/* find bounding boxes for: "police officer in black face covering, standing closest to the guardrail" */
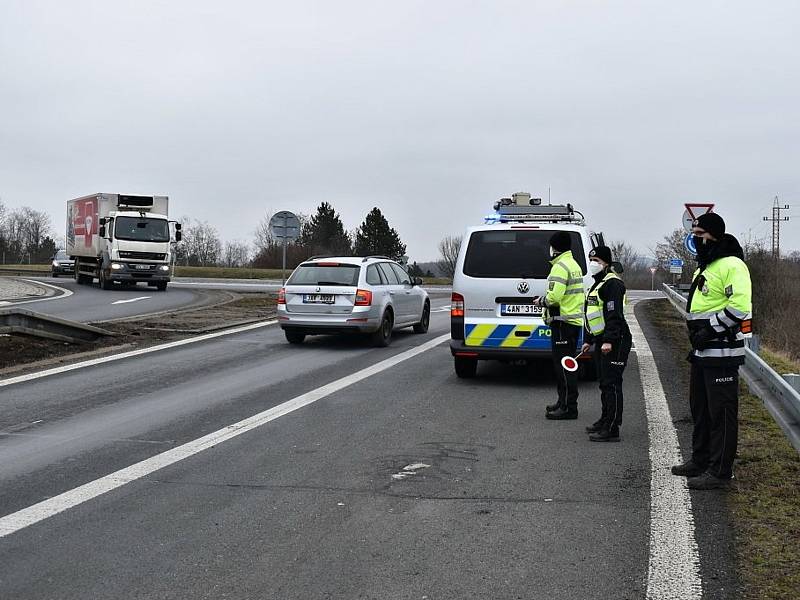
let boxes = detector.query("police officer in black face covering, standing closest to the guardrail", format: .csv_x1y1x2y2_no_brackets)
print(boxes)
672,213,752,489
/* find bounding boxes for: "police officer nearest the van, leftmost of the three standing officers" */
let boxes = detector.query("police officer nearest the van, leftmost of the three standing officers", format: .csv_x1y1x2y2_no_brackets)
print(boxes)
534,231,585,420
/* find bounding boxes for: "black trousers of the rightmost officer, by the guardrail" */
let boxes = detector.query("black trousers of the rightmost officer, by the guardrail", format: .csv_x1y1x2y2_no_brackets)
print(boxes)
689,362,739,479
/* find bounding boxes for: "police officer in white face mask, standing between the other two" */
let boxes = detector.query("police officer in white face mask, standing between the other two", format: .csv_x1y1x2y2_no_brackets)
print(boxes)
581,246,633,442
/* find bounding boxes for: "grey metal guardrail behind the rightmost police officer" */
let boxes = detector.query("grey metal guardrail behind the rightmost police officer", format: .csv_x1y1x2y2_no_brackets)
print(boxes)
663,283,800,452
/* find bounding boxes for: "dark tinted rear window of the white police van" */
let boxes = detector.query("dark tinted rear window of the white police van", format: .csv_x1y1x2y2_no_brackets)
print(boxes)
464,229,586,279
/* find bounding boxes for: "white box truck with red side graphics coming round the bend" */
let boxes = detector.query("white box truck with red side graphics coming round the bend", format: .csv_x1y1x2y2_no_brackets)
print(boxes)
66,194,181,291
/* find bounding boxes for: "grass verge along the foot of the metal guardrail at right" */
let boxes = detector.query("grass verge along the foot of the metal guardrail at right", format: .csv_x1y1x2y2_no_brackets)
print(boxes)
648,301,800,600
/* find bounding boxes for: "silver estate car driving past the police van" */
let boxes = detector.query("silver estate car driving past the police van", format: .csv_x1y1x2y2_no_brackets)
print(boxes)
278,256,431,346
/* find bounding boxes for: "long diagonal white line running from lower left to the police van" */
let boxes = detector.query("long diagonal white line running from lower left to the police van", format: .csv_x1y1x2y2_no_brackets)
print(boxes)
0,333,450,537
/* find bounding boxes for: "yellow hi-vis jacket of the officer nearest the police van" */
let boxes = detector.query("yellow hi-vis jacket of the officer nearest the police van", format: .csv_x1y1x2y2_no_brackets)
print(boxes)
544,251,586,327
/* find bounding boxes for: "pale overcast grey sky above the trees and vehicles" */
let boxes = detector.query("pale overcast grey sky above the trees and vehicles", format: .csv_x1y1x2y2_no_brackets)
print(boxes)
0,0,800,260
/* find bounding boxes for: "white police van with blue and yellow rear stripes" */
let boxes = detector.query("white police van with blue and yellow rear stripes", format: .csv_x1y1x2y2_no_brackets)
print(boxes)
450,192,603,377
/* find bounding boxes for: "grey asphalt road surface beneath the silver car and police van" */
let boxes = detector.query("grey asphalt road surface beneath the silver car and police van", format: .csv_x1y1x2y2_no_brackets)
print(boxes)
0,294,668,599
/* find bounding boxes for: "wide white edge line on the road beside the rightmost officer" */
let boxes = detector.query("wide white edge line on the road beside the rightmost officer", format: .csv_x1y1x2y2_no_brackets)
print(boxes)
627,308,703,600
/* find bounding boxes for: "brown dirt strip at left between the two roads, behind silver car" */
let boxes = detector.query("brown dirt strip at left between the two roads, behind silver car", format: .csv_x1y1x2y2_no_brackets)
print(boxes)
0,292,276,378
